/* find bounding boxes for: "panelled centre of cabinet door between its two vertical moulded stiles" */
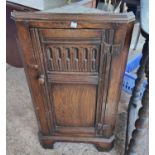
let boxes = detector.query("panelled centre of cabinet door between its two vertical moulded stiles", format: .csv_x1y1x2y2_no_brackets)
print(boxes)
34,29,101,135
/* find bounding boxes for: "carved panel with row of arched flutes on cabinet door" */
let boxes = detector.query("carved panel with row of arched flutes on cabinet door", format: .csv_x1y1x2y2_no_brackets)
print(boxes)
45,44,100,72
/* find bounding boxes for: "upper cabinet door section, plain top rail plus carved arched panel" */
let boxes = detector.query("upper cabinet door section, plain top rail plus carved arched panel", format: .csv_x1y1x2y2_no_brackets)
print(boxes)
39,29,101,72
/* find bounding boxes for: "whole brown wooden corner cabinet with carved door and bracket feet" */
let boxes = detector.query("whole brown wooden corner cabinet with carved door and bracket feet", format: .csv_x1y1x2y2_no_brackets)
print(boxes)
12,12,134,149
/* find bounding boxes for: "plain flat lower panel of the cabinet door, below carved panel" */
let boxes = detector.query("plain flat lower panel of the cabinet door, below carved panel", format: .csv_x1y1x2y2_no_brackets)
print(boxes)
51,84,96,127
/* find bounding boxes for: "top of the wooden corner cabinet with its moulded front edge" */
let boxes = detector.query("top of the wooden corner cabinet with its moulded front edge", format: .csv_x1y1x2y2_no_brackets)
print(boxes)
11,6,135,23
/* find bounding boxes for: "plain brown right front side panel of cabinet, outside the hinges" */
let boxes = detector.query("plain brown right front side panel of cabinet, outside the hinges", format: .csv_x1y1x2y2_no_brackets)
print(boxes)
103,22,133,137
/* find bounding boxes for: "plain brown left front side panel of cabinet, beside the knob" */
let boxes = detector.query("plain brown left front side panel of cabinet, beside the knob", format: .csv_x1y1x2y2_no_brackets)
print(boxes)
16,21,50,135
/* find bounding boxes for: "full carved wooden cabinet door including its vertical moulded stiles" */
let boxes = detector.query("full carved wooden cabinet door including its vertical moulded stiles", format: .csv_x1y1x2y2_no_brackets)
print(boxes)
30,28,128,136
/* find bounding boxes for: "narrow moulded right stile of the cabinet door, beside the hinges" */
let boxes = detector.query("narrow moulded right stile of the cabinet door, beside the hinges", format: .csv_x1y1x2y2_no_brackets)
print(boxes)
96,30,113,136
